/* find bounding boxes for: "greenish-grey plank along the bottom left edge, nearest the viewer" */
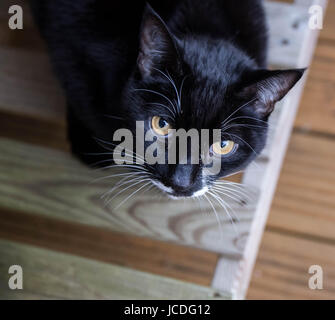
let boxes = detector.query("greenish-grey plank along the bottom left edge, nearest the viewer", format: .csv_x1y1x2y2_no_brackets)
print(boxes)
0,240,229,300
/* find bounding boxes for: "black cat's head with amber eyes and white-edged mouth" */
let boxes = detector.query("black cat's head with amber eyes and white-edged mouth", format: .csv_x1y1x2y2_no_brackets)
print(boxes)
119,7,304,197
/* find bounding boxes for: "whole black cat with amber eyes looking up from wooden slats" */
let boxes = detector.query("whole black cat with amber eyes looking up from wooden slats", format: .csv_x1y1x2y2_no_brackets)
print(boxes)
31,0,304,197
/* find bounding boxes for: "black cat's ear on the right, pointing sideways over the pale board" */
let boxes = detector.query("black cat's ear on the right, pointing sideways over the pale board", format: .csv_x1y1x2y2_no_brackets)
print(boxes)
239,69,306,117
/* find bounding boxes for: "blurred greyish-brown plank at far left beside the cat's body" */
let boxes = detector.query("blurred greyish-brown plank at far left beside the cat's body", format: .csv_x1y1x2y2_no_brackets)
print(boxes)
0,47,65,127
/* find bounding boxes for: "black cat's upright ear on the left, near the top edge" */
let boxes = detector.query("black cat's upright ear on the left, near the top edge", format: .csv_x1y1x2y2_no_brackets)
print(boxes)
137,4,179,77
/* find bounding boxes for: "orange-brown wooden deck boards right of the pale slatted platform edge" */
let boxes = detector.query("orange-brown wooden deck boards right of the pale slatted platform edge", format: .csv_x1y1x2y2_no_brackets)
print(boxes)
247,0,335,299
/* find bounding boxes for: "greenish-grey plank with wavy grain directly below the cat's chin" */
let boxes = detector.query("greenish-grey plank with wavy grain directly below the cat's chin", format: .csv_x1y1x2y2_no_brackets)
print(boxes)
0,139,257,258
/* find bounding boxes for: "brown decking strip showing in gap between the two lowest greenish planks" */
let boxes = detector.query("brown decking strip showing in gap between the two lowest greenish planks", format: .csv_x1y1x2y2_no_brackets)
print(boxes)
0,208,217,286
